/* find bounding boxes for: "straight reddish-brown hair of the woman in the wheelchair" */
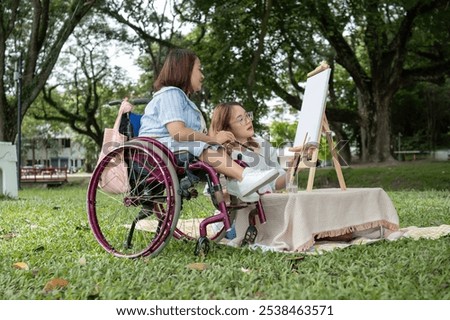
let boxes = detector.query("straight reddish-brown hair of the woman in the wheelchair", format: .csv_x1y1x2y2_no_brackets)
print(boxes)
153,48,198,94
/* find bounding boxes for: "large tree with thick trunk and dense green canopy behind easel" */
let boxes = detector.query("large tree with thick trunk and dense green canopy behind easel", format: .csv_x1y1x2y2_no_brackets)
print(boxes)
184,0,450,161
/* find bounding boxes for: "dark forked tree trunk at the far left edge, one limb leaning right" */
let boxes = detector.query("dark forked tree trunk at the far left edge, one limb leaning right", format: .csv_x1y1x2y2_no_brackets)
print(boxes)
0,0,95,142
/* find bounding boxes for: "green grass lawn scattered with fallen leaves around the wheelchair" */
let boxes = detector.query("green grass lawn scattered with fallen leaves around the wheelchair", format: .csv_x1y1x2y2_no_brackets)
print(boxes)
0,163,450,300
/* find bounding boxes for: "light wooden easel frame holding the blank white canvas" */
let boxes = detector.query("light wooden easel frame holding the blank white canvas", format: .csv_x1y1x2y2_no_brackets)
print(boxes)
289,62,347,191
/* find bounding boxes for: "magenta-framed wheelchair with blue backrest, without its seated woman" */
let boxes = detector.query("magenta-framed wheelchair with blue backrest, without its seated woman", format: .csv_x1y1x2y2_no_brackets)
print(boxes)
86,113,266,258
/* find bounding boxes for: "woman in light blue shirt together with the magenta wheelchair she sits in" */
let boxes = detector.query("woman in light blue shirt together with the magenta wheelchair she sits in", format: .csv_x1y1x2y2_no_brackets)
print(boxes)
87,49,279,258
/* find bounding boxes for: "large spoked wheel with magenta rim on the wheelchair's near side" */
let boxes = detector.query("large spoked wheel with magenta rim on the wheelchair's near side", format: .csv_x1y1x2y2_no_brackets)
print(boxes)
87,141,181,258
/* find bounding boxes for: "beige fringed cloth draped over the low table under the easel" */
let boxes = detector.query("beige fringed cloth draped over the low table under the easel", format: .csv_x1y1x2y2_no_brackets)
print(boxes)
229,188,399,251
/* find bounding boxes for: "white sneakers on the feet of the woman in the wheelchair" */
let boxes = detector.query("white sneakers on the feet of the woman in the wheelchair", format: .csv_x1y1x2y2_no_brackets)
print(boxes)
227,168,279,202
